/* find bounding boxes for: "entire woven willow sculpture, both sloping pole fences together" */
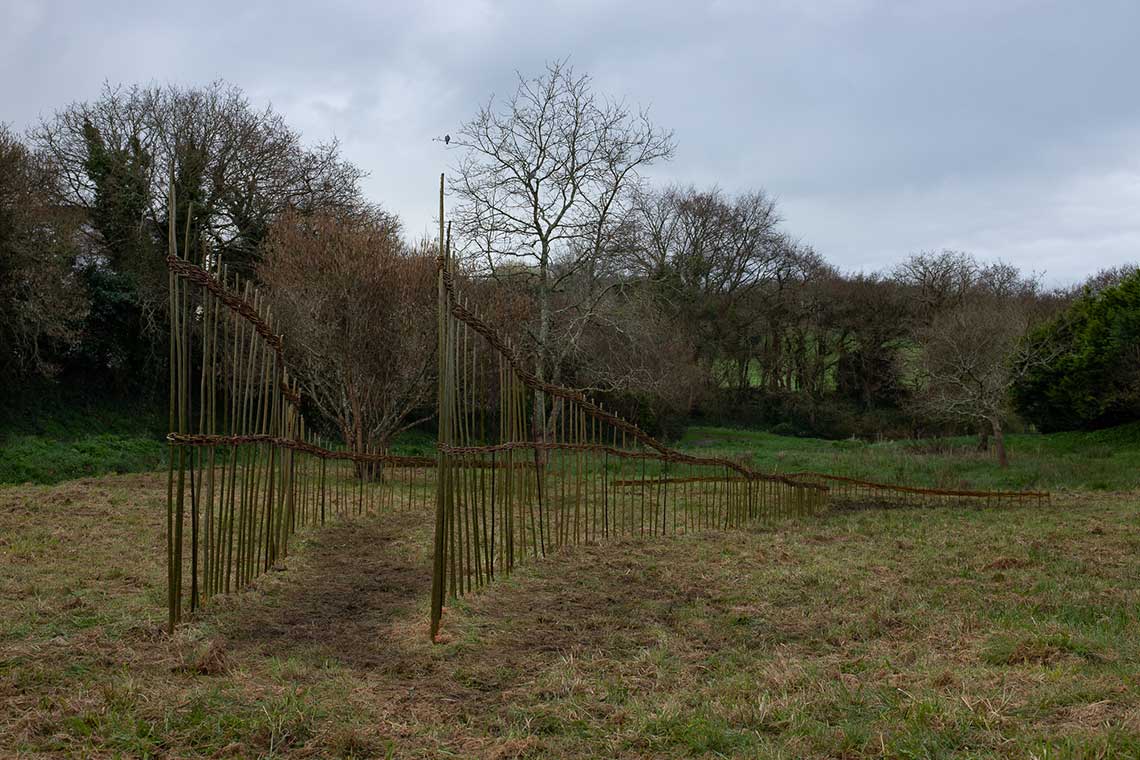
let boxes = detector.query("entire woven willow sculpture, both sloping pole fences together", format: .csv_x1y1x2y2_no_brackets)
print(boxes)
166,178,1049,638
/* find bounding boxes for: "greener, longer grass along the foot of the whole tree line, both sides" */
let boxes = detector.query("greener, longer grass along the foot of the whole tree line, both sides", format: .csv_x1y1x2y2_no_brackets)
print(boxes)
8,404,1140,491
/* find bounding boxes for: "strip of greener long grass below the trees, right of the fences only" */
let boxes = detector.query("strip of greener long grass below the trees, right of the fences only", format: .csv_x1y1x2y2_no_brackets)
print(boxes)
679,423,1140,491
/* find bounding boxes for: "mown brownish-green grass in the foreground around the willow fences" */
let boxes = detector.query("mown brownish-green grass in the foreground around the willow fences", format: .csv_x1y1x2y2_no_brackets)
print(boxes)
0,471,1140,758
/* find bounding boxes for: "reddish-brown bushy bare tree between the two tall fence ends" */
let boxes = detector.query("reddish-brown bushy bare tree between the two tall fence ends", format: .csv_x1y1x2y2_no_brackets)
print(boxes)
260,209,435,464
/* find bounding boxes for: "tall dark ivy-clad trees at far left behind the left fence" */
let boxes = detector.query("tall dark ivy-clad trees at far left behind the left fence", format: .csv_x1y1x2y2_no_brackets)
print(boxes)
0,82,361,393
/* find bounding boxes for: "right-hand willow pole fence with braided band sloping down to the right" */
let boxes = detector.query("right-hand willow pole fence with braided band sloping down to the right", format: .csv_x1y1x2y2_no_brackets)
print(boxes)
431,175,828,639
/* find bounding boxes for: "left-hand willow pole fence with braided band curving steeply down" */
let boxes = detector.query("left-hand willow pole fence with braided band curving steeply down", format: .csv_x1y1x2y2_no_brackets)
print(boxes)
166,184,435,629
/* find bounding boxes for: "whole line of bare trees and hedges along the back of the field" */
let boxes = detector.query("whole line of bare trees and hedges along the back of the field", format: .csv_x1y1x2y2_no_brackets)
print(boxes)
0,74,1140,460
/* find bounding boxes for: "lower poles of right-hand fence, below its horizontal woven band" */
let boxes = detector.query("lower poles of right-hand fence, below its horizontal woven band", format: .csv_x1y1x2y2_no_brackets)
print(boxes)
443,448,827,595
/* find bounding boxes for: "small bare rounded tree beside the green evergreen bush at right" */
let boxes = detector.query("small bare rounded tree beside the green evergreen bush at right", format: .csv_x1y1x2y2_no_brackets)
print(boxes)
903,278,1049,467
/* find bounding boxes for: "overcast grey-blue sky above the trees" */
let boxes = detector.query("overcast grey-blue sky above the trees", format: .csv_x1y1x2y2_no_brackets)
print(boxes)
0,0,1140,284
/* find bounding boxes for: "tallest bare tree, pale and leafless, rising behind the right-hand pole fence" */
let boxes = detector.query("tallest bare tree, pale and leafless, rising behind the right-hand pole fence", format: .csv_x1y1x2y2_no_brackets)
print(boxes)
450,63,673,435
